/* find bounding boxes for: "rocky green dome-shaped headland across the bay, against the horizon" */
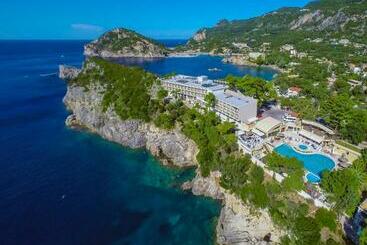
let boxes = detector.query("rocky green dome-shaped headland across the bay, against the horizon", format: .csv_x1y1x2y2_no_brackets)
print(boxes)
84,28,167,58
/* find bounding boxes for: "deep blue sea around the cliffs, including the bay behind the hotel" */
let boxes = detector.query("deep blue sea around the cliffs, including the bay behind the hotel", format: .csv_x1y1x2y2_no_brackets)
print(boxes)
0,41,274,245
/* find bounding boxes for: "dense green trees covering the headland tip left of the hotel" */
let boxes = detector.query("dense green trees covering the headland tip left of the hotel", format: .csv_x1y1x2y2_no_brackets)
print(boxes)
70,58,157,121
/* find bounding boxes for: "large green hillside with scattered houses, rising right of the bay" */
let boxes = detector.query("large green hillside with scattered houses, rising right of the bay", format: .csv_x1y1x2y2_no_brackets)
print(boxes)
185,0,367,144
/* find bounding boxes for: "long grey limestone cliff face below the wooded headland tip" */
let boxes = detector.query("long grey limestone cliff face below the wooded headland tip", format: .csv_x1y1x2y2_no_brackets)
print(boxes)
64,86,198,167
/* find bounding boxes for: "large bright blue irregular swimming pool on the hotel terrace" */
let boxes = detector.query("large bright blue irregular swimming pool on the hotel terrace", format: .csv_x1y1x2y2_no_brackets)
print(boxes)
274,144,335,183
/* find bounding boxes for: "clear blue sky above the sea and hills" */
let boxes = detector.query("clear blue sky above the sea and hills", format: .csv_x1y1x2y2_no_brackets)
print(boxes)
0,0,309,39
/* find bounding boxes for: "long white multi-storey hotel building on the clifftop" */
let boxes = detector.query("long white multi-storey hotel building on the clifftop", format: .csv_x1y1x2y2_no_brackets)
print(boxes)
162,75,257,123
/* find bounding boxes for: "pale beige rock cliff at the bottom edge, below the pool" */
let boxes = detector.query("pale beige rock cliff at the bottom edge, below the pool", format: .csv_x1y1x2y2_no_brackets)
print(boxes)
182,172,283,245
